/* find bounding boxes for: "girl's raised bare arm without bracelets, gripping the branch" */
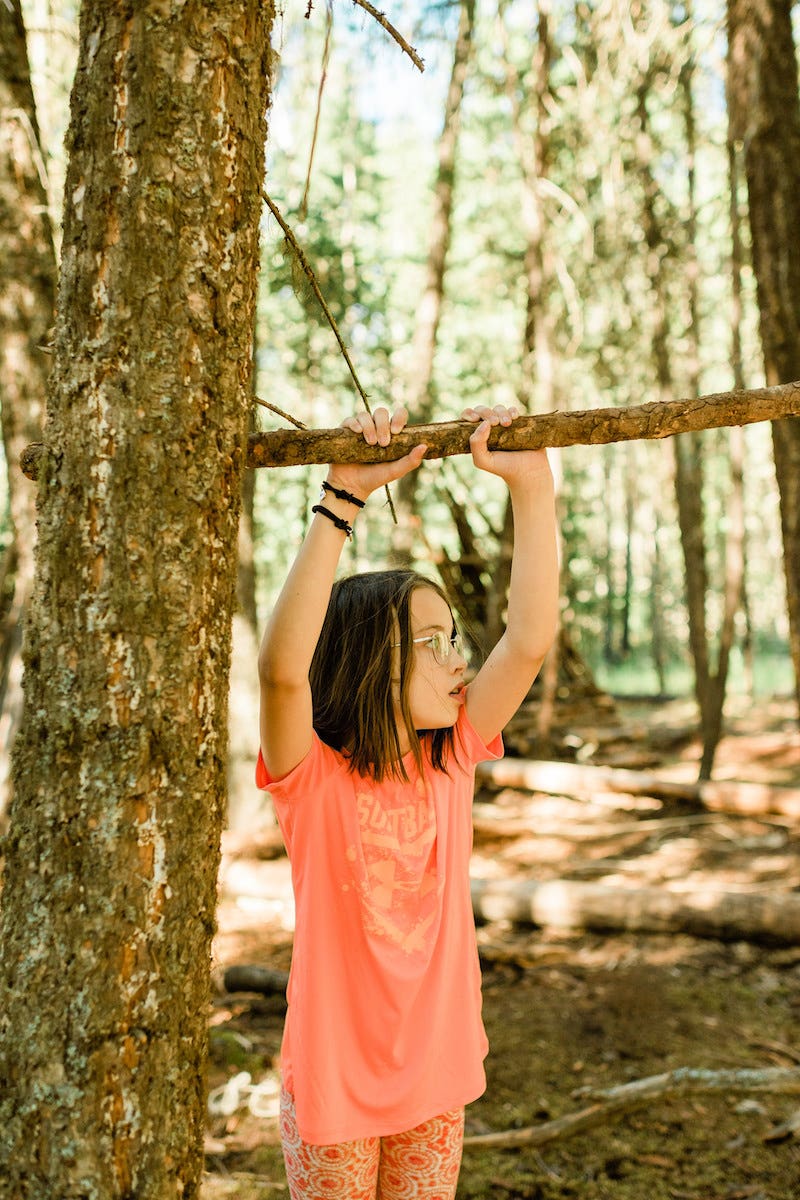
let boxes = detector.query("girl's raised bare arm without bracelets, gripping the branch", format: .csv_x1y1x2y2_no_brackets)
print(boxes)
463,406,559,742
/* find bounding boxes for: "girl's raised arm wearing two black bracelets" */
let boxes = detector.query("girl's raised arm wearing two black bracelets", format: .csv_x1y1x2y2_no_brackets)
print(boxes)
258,408,427,779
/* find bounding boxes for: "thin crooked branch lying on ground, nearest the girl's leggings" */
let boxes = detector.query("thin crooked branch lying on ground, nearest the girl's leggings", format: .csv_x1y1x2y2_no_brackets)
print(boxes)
464,1067,800,1150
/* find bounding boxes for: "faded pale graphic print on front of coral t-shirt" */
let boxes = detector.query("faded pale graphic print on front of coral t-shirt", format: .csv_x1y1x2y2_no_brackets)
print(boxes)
343,779,443,954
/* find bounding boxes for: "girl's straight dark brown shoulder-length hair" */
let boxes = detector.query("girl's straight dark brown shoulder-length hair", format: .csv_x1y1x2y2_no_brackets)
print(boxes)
309,570,453,782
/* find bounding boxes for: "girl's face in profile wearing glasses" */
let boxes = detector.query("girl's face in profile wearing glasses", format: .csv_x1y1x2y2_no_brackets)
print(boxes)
395,587,467,751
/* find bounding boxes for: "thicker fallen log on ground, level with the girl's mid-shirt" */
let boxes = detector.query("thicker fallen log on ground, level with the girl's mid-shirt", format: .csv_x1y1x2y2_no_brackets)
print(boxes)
471,880,800,946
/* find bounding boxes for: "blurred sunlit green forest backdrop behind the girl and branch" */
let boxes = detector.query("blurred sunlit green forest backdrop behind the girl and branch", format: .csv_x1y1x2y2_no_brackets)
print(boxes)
2,0,793,825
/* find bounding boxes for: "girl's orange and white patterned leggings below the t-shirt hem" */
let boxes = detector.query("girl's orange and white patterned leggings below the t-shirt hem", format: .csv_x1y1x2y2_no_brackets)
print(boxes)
281,1091,464,1200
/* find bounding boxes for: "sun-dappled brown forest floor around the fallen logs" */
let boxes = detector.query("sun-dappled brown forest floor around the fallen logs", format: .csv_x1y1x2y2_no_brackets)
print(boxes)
203,701,800,1200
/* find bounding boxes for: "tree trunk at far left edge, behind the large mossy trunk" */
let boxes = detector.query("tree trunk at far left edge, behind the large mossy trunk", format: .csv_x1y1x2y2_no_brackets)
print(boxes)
0,0,56,828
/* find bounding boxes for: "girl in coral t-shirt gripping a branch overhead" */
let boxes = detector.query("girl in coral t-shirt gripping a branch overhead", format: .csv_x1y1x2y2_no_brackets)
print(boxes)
257,407,558,1200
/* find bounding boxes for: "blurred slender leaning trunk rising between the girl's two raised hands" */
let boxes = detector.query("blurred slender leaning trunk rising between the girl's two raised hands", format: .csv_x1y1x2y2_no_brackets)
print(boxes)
392,0,475,566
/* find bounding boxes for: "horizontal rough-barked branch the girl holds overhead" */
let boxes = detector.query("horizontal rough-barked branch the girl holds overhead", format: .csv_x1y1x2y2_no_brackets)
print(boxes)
20,380,800,479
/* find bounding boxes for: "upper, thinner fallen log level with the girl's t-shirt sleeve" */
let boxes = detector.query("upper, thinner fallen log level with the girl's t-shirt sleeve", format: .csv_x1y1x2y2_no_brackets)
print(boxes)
477,758,800,818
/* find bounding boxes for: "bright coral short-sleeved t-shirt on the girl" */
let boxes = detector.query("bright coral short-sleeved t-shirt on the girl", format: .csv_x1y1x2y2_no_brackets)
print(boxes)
255,707,503,1145
